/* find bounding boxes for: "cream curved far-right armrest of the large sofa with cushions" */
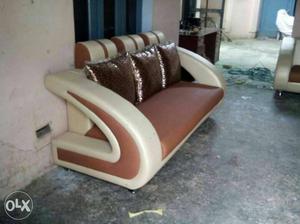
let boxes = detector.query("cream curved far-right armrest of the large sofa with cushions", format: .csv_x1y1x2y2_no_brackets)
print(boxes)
177,47,226,90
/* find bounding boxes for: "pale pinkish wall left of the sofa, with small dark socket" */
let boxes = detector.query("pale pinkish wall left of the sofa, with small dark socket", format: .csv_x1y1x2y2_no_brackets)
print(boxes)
0,0,74,197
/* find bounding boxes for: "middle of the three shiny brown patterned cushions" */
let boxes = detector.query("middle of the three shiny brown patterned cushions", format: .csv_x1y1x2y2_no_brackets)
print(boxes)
131,46,163,103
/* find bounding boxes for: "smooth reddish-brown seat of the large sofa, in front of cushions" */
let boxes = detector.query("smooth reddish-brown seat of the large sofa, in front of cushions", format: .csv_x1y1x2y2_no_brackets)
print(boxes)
137,82,224,158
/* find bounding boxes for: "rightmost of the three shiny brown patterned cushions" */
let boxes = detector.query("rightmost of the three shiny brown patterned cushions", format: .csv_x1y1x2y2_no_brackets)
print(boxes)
157,43,181,86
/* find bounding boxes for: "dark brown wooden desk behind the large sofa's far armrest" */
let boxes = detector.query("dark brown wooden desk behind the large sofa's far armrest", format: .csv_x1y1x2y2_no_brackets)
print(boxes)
179,28,221,64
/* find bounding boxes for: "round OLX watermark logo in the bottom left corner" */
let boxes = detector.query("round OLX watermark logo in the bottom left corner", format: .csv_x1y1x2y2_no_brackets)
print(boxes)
4,191,33,220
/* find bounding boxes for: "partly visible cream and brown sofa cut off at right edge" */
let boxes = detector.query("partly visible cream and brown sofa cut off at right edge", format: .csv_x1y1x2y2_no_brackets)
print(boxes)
274,37,300,96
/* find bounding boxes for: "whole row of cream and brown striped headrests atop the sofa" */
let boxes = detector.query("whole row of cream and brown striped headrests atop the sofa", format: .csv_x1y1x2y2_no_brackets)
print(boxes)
75,31,166,68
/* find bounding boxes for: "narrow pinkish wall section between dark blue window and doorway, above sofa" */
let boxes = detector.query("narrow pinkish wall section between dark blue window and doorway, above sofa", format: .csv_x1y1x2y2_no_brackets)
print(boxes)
152,0,181,43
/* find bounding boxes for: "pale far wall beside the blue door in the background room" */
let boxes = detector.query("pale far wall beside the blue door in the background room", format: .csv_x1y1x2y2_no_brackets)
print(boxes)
223,0,261,38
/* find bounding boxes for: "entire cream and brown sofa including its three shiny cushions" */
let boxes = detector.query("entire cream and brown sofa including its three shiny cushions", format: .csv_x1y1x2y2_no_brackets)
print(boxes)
45,31,225,189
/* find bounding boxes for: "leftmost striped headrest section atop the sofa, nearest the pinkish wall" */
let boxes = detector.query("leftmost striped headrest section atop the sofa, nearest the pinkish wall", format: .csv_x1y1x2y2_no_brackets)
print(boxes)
75,39,118,68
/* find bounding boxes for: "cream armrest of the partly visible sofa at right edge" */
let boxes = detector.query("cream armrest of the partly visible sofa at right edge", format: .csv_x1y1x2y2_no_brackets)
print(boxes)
274,37,295,90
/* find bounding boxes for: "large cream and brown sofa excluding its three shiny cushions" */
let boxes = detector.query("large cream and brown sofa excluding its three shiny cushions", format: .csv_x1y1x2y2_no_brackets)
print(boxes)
45,31,225,189
